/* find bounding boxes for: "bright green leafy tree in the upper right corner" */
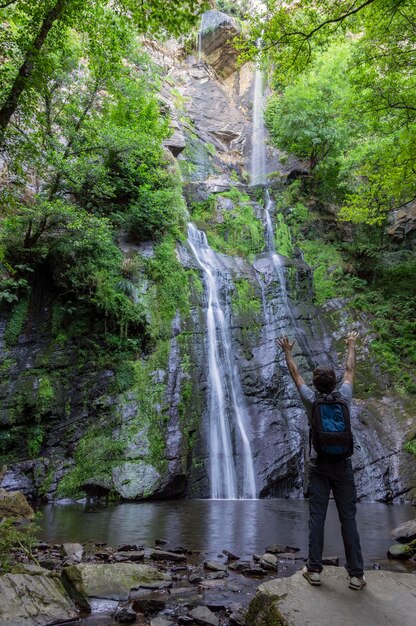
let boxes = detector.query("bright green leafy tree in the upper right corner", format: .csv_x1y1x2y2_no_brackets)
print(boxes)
254,0,416,223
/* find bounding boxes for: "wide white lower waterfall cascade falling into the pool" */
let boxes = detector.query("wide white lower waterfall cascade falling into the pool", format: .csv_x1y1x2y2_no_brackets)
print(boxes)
188,224,256,499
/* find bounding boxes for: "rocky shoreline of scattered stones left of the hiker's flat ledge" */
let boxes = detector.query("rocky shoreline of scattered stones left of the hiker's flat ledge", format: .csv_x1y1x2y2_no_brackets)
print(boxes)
0,539,304,626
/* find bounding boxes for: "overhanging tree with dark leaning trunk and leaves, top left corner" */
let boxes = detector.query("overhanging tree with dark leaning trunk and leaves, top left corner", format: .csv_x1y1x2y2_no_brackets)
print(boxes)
0,0,206,138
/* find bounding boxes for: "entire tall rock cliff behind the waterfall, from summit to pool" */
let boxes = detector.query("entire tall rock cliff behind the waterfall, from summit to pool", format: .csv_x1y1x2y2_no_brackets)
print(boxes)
0,11,415,500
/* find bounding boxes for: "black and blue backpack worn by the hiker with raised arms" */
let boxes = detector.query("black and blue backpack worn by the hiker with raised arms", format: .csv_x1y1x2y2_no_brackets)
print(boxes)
310,391,354,461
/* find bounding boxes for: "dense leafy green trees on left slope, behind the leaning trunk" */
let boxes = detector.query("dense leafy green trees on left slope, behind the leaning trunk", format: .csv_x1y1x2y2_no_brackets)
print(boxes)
0,14,188,343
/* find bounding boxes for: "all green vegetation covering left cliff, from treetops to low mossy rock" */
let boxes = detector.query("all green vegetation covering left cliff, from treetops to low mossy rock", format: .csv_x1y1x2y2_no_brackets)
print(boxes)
0,0,204,478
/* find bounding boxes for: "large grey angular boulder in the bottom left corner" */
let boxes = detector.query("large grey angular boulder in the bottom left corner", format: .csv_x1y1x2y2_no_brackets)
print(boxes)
0,568,78,626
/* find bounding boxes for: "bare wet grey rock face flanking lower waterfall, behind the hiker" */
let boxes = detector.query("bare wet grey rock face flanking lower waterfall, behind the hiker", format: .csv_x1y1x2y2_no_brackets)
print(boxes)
181,230,415,501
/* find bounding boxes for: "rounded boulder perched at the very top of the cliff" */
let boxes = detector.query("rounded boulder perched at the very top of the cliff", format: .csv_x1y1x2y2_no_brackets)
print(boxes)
200,11,240,78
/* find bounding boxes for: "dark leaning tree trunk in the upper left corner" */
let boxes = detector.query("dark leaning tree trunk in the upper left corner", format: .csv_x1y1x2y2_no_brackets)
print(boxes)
0,0,67,137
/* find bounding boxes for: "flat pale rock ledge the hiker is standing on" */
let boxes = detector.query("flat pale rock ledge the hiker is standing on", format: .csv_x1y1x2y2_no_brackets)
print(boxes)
246,567,416,626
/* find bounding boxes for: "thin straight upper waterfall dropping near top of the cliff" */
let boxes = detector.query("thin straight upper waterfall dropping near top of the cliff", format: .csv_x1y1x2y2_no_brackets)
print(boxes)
250,43,266,185
